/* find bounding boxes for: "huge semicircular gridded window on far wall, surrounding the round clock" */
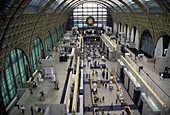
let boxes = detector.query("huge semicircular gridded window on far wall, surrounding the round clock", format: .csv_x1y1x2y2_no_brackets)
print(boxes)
69,2,113,29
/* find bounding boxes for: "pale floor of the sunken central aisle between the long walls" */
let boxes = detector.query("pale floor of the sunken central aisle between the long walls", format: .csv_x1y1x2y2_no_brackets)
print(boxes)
84,42,140,115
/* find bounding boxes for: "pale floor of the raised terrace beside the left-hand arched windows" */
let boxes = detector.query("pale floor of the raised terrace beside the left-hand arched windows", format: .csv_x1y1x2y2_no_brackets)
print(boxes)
10,49,70,115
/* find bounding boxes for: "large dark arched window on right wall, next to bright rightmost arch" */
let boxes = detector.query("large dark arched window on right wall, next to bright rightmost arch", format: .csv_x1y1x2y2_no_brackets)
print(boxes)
140,30,154,58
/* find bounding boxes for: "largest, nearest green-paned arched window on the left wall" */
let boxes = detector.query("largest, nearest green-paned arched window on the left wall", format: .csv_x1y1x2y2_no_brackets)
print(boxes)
1,49,30,107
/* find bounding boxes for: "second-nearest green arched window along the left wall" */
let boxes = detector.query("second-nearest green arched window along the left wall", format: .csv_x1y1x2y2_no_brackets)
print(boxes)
31,38,44,72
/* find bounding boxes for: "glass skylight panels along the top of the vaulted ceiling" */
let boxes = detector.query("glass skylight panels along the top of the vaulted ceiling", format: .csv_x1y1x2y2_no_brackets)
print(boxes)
0,0,165,15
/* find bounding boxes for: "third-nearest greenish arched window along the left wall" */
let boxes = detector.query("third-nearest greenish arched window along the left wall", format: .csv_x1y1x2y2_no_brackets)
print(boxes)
45,32,53,56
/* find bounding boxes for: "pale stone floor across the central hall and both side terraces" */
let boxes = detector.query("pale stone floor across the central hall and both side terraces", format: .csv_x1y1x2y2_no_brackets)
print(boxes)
10,40,170,115
